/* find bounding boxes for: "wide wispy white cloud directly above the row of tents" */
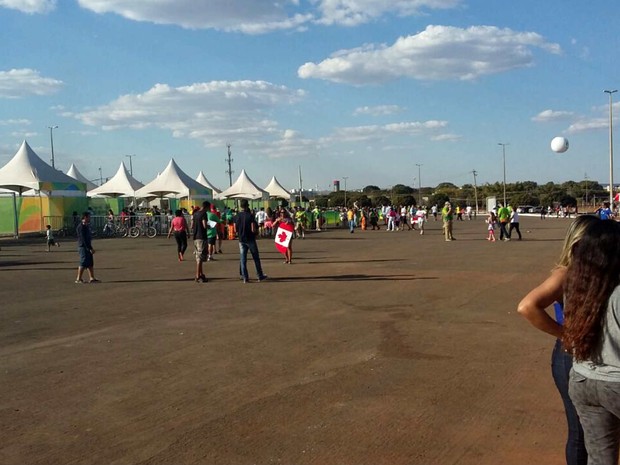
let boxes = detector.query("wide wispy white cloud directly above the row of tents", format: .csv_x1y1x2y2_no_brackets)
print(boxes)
69,81,304,146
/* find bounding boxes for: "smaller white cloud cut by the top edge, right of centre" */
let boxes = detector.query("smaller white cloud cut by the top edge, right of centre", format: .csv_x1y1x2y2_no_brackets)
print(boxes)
318,0,461,26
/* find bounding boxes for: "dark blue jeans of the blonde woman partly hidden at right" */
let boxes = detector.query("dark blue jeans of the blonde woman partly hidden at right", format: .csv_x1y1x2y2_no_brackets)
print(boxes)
551,339,588,465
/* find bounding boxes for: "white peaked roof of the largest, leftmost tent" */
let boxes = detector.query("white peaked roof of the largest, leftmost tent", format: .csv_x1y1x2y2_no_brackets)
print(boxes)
0,141,86,193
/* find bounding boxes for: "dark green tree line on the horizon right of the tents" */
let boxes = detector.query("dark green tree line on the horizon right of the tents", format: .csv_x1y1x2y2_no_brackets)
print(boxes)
314,180,609,209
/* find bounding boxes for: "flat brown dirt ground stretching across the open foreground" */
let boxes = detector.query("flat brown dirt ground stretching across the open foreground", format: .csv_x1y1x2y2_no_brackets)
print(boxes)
0,217,569,465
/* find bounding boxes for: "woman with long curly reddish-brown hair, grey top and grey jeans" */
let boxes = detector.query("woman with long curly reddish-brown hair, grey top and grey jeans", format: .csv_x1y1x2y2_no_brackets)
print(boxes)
562,221,620,465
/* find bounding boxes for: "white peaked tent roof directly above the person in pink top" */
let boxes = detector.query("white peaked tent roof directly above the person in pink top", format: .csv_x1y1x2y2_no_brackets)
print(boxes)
136,159,211,198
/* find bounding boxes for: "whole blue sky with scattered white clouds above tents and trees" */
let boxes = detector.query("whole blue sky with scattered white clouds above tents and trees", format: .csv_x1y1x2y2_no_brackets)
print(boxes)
0,0,620,190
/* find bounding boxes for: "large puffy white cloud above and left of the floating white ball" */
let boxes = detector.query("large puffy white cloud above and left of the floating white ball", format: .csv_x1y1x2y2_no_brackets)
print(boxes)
297,26,561,85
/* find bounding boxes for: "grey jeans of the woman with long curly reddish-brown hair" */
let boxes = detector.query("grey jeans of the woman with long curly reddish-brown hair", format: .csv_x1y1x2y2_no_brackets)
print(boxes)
569,370,620,465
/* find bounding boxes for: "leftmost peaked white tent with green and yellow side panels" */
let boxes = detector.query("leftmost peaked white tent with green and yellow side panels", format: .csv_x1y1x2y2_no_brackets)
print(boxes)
0,141,87,236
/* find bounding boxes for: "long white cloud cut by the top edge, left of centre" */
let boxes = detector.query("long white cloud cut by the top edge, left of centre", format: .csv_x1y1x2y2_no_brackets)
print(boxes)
78,0,313,34
